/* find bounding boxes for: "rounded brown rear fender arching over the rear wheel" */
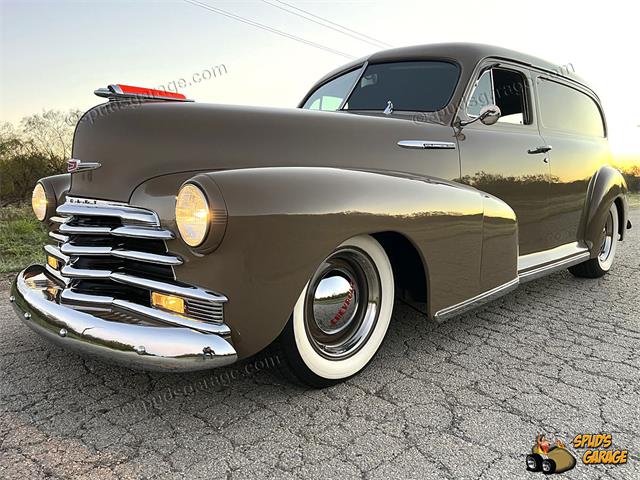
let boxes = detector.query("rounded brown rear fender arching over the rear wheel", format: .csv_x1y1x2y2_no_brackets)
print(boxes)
580,165,629,253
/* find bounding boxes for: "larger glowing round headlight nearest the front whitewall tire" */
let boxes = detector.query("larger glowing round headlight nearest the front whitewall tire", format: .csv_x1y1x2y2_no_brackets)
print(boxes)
176,183,211,247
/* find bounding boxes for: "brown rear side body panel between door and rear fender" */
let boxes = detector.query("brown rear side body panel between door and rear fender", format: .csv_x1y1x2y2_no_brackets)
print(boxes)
533,72,610,251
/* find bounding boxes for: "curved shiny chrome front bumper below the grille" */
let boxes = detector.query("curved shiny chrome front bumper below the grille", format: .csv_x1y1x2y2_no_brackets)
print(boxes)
11,265,237,371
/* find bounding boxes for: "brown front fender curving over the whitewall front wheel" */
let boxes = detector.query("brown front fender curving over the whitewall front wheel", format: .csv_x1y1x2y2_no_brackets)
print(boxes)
131,167,508,358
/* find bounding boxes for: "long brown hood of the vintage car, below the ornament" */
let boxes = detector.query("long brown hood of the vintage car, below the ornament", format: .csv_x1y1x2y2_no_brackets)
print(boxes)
69,102,457,202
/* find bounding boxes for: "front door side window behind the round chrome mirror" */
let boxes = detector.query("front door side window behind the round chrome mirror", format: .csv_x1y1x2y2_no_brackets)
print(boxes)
467,68,532,125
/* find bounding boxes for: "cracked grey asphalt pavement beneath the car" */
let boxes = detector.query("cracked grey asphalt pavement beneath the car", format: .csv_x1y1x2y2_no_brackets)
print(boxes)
0,210,640,480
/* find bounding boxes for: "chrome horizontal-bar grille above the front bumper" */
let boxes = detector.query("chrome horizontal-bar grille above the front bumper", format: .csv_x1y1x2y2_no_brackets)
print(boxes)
44,197,229,335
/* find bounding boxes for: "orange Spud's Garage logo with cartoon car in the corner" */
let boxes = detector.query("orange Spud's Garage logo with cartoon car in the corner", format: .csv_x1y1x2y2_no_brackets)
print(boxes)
526,433,628,475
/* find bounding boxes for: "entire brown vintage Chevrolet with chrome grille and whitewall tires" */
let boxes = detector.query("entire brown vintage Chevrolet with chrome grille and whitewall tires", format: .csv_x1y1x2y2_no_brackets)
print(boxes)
12,44,630,386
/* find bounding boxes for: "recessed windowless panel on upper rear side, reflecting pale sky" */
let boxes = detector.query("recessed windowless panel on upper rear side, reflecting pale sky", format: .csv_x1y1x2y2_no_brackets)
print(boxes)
538,79,604,137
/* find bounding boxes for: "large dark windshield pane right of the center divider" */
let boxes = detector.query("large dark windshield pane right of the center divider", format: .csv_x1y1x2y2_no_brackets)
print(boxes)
344,61,460,112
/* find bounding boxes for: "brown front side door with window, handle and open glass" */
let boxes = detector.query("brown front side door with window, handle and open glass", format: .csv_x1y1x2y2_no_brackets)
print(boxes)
458,61,549,256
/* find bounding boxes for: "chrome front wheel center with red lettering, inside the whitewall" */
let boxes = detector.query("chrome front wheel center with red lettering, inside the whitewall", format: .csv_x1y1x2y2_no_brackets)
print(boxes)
305,247,381,360
